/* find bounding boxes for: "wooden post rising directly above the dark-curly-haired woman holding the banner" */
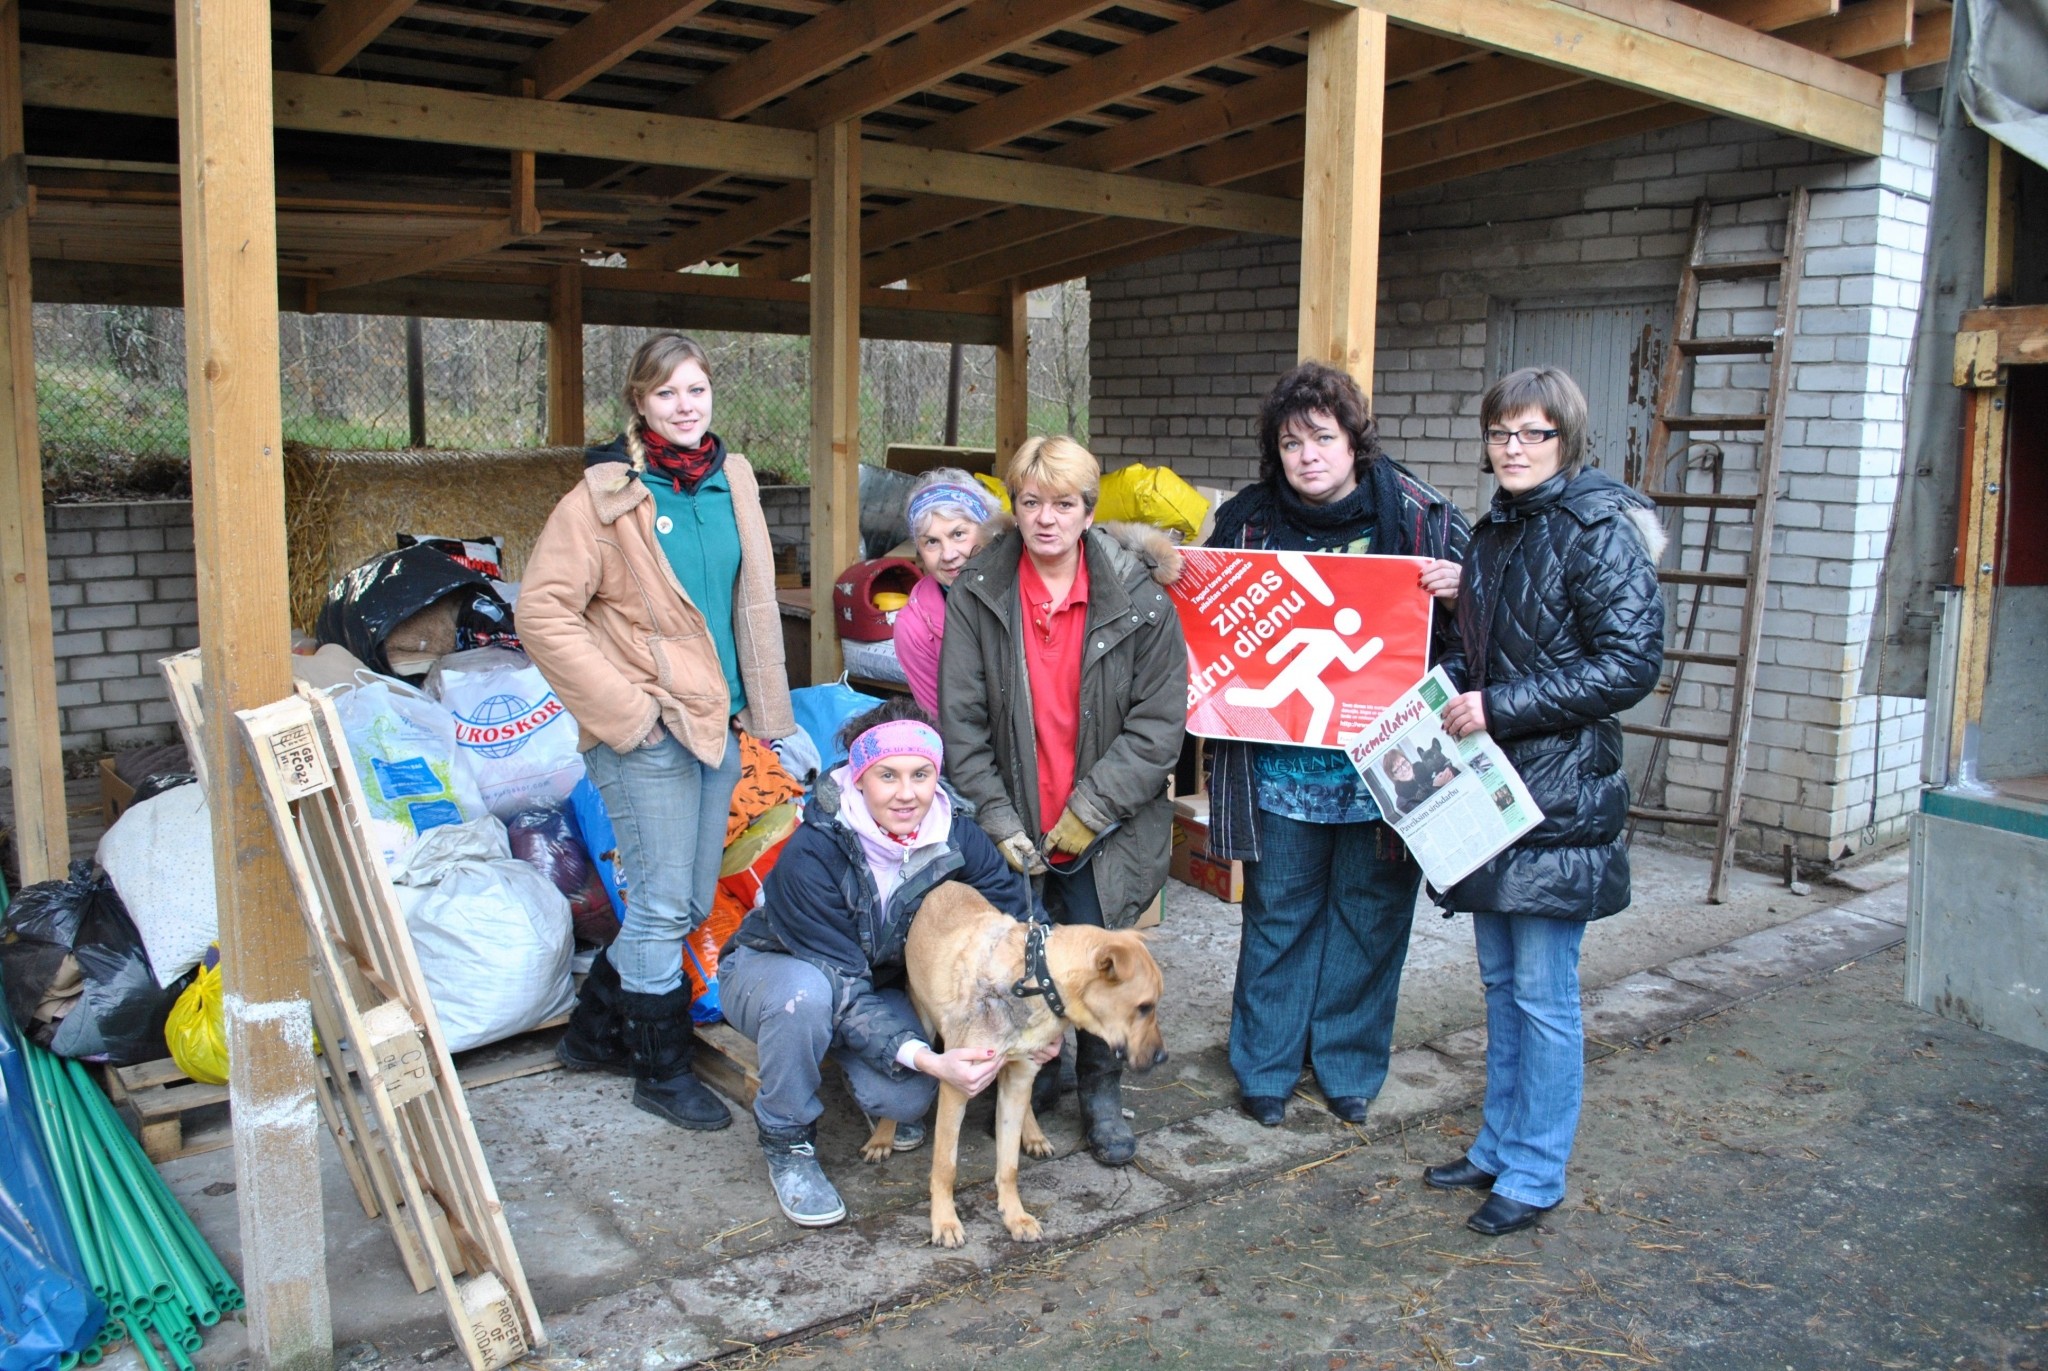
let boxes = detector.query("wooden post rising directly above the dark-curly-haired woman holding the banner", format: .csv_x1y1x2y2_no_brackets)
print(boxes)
1300,10,1386,396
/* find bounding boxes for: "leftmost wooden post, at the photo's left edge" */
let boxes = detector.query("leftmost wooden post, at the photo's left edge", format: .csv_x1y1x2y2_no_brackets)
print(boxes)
0,0,72,883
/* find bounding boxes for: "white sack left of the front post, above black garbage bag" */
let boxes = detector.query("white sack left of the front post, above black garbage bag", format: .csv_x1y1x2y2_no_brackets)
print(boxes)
96,785,219,988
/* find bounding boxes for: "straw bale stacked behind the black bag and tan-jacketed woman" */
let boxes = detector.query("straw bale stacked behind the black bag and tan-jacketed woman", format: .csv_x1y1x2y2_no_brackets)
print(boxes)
285,443,584,633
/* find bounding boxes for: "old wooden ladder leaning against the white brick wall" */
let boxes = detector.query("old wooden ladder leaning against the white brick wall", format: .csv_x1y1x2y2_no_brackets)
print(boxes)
1622,191,1806,904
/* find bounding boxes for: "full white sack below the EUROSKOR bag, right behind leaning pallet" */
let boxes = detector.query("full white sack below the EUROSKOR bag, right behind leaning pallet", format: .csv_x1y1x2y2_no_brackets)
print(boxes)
391,814,575,1051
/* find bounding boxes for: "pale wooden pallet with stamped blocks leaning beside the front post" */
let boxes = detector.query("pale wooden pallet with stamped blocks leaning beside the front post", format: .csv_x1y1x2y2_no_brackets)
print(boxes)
238,687,547,1371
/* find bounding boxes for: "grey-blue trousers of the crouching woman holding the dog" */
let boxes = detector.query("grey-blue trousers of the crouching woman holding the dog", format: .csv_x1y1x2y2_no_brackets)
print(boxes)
719,947,938,1129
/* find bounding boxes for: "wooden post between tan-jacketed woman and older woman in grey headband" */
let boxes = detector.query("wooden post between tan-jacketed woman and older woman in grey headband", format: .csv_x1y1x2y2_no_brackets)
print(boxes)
811,119,860,682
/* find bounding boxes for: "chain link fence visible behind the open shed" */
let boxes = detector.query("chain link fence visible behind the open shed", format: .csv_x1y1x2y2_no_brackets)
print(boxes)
35,283,1087,492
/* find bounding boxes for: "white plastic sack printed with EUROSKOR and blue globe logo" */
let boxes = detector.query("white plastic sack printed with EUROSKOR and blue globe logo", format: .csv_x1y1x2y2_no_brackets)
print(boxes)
426,648,584,818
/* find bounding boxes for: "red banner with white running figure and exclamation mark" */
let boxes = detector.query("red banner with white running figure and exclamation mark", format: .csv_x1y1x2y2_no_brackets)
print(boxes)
1174,547,1430,748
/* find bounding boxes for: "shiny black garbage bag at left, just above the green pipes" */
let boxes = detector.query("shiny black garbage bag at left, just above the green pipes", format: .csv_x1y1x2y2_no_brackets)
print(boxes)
0,861,186,1066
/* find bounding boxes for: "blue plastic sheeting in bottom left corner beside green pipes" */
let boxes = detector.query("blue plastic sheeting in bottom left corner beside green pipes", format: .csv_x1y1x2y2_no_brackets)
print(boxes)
0,1014,106,1371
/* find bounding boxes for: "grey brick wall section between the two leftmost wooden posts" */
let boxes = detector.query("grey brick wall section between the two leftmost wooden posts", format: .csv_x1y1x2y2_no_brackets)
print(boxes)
0,500,199,764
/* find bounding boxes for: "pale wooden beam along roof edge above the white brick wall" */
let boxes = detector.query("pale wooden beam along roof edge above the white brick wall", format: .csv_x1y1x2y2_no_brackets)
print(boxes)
1358,0,1884,156
